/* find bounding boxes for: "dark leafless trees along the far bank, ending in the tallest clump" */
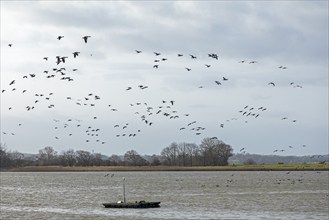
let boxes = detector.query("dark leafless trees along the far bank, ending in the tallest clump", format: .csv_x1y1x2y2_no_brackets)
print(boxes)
0,138,233,168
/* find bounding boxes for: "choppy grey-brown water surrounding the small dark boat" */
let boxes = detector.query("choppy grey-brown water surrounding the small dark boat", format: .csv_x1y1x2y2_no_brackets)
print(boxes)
0,171,329,220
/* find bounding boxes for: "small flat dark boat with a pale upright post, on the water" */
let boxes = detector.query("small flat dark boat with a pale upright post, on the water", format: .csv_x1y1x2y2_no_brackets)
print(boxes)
103,178,161,208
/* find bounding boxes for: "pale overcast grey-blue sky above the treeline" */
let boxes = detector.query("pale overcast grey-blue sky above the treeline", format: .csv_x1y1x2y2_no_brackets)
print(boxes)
1,1,328,155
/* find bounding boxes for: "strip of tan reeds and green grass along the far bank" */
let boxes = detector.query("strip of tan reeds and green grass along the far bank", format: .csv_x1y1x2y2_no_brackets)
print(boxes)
0,163,329,172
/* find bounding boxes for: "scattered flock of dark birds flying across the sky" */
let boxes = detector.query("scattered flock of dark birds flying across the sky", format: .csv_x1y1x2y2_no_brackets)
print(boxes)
1,36,305,153
